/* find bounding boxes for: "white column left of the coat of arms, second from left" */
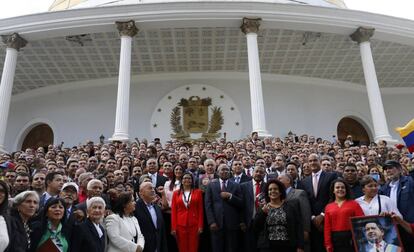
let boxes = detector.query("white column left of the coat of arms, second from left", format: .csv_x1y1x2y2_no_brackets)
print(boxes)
109,21,138,141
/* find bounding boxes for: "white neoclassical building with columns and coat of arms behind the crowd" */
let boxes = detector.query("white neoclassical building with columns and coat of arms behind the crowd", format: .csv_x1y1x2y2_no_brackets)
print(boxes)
0,0,414,151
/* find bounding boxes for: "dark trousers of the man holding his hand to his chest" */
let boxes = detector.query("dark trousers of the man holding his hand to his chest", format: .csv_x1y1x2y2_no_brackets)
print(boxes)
211,229,238,252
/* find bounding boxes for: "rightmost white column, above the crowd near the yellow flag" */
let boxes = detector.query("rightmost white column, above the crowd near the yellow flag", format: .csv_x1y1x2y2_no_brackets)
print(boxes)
351,27,395,142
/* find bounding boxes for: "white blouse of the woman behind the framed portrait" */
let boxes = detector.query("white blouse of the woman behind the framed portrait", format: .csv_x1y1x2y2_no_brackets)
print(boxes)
355,194,402,216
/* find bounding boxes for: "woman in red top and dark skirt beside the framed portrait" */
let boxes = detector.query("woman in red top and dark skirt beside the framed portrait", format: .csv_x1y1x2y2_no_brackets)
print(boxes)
324,179,364,252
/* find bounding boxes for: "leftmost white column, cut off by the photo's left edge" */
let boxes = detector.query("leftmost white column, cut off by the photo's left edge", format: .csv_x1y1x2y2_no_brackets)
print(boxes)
0,33,27,153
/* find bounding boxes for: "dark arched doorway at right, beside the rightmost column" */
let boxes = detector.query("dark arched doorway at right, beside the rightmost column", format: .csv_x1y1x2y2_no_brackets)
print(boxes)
337,117,371,145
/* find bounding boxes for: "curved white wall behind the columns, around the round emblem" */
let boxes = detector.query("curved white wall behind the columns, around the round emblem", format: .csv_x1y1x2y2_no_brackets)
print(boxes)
6,72,414,151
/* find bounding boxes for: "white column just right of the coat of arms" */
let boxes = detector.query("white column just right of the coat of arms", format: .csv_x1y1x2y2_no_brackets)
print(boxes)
240,18,270,137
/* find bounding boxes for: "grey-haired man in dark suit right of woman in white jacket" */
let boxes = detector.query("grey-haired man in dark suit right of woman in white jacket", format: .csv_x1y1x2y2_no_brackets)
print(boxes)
135,182,168,252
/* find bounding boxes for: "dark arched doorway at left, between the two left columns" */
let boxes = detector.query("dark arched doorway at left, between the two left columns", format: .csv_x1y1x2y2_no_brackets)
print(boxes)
22,123,53,150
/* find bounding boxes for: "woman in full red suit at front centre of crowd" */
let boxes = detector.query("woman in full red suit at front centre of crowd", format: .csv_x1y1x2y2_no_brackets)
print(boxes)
171,173,204,252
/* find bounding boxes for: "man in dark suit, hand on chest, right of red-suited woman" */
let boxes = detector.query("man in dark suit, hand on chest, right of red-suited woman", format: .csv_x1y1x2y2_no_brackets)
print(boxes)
205,164,243,252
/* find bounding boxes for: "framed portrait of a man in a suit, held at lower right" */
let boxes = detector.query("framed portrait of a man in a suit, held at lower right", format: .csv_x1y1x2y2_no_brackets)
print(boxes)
351,216,403,252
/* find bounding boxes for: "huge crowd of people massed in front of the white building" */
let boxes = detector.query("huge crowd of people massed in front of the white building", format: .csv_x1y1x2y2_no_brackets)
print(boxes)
0,133,414,252
